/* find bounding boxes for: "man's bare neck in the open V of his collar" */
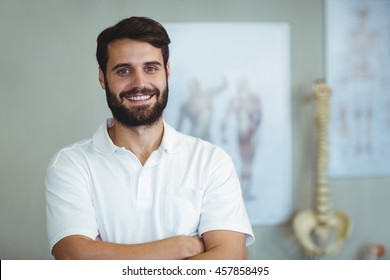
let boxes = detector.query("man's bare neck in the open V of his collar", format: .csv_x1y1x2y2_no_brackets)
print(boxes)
108,118,164,165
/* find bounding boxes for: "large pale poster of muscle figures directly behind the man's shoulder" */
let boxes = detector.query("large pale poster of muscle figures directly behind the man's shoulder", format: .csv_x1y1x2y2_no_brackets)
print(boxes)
164,23,292,225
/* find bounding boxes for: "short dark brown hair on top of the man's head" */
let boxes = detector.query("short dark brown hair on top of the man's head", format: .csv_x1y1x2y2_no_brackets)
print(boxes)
96,17,171,74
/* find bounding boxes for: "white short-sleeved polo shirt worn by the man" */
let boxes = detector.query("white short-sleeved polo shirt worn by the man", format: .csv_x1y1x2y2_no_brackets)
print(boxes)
46,119,254,252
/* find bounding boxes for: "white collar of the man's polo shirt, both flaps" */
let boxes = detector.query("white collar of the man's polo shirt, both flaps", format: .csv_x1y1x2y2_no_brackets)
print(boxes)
92,118,181,155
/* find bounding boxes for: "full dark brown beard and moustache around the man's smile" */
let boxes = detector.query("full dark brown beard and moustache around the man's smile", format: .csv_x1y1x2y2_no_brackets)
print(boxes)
105,80,169,128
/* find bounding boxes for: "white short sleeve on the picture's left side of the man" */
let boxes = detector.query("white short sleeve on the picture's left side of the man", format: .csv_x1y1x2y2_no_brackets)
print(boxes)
45,151,98,251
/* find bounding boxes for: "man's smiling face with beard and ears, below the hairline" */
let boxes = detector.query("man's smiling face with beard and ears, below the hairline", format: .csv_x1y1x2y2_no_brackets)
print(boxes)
99,39,169,127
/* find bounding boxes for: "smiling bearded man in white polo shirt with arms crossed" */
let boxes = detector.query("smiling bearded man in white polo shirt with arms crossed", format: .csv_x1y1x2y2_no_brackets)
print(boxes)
46,17,253,259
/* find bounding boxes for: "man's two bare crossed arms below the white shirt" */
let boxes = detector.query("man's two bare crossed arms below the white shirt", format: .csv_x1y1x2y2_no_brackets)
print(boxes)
52,230,246,260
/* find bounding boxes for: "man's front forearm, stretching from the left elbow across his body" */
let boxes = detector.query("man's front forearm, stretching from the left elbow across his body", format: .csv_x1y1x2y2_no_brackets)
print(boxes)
53,236,203,260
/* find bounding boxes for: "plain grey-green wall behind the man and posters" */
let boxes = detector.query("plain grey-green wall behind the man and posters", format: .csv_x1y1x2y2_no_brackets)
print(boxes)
0,0,390,259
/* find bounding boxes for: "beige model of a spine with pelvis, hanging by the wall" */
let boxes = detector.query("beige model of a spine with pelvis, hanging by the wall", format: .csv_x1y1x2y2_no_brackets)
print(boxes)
293,80,352,256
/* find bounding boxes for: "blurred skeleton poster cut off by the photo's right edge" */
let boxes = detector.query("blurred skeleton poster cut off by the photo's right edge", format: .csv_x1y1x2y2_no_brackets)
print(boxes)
326,0,390,178
